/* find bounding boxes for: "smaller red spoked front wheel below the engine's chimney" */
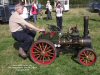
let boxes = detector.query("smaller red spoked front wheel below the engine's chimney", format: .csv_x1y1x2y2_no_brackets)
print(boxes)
78,48,97,66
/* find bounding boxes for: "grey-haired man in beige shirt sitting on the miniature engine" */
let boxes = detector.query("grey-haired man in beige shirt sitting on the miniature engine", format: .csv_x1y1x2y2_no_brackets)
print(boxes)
9,3,45,58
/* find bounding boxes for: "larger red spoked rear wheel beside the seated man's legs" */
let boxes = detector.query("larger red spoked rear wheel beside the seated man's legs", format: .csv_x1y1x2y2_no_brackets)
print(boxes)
30,40,56,65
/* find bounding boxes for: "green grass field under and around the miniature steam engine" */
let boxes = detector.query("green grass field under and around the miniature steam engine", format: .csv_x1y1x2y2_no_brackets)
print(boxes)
0,8,100,75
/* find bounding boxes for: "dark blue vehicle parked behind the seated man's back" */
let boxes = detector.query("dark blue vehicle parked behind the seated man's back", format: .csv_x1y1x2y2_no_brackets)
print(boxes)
0,0,31,22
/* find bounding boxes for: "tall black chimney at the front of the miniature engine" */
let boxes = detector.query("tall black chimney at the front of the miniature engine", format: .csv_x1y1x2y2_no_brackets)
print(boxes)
83,16,89,38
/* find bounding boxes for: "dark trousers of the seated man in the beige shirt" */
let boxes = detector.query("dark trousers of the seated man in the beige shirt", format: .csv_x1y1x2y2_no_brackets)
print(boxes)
12,29,36,52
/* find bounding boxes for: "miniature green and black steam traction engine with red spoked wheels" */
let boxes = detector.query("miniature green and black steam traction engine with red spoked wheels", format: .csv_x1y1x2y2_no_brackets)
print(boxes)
29,16,96,66
